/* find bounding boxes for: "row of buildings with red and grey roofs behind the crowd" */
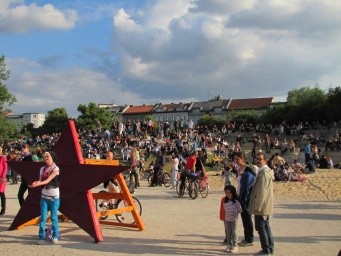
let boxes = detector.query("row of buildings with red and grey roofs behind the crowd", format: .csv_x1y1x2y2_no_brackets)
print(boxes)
3,95,278,128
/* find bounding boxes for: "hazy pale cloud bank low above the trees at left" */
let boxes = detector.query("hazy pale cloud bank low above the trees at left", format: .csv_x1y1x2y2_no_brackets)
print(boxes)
7,59,142,116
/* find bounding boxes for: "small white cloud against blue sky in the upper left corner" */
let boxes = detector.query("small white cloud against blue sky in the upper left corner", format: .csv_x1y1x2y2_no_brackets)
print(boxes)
0,1,77,33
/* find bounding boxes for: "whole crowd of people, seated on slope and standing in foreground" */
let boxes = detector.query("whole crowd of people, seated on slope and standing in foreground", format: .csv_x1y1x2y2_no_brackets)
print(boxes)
0,119,340,251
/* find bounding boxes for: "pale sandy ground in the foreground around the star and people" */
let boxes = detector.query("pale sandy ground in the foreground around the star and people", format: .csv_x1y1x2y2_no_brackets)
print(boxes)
0,170,341,256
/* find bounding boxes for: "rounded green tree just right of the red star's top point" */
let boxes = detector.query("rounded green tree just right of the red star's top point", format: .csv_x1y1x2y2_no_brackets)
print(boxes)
77,102,114,131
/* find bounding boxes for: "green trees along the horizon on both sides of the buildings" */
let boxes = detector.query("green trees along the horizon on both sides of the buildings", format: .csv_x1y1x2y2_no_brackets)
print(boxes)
0,56,341,142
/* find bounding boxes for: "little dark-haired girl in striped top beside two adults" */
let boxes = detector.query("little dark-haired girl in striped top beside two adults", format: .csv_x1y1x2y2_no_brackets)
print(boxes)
220,185,242,253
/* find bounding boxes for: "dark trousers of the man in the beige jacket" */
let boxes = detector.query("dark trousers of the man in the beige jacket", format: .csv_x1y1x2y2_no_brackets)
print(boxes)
255,215,274,254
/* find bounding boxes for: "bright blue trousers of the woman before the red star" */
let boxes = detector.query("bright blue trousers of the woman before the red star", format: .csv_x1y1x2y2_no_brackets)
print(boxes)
39,197,60,240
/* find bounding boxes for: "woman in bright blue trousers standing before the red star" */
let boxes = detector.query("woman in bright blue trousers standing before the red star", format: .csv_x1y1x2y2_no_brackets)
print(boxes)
28,151,60,245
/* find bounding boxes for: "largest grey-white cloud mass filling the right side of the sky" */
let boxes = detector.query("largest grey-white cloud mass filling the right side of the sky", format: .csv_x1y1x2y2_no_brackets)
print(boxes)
109,0,341,98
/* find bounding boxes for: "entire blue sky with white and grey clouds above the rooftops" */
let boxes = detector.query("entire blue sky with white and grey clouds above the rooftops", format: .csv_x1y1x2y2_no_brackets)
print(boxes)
0,0,341,116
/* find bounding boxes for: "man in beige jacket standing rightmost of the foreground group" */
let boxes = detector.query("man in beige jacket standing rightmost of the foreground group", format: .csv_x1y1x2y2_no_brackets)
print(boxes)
249,153,274,255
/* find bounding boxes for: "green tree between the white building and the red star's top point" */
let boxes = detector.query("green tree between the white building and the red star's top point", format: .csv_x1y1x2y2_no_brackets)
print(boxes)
41,108,69,134
